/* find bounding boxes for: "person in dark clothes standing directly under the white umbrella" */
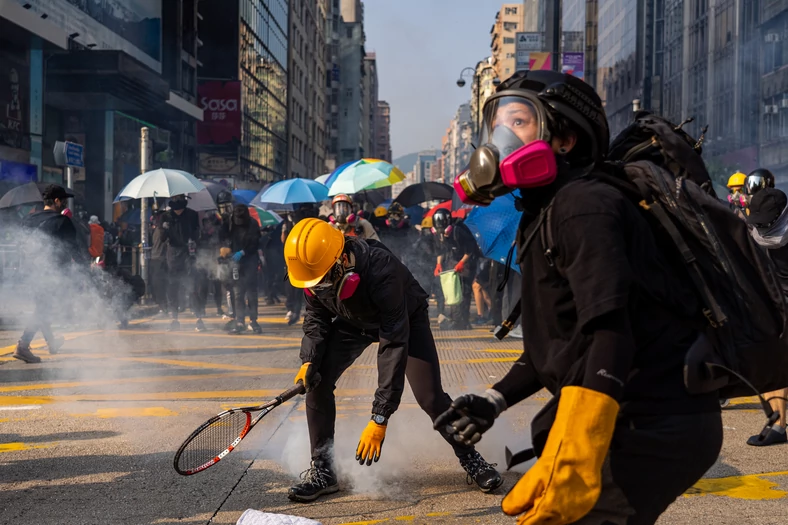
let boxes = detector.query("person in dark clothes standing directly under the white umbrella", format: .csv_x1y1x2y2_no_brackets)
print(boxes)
161,195,205,331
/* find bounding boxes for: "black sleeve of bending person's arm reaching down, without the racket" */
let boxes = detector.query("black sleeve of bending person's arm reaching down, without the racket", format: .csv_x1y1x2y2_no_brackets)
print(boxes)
370,254,410,417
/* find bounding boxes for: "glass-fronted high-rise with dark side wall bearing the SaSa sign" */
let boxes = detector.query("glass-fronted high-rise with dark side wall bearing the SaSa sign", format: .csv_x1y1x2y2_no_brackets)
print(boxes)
197,0,289,189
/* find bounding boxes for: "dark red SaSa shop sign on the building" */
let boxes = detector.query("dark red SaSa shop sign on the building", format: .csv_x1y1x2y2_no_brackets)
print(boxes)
197,80,241,145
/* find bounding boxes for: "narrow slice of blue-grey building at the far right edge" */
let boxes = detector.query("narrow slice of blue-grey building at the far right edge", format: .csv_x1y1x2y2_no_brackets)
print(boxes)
758,0,788,179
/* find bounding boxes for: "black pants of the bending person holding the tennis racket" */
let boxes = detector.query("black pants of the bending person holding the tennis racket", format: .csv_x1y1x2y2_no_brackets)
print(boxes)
306,308,473,460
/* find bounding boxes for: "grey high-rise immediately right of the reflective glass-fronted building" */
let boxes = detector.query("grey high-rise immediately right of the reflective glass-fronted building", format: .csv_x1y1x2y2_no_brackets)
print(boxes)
287,0,326,179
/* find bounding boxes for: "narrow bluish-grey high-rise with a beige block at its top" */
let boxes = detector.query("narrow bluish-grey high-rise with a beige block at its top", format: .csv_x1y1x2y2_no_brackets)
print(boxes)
337,0,369,165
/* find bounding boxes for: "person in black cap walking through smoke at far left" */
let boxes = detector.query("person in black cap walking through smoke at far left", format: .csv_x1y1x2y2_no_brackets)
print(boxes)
13,184,82,363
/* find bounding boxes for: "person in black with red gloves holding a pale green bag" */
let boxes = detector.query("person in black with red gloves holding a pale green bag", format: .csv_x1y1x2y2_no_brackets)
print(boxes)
432,208,479,330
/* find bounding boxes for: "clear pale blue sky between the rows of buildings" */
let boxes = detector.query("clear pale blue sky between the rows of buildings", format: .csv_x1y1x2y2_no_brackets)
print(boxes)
364,0,503,158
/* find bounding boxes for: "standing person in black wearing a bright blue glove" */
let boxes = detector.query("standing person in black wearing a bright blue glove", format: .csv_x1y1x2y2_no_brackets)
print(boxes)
222,204,262,334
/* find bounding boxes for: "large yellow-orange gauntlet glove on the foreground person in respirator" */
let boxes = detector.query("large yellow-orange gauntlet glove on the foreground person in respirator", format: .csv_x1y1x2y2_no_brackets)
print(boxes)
501,386,618,525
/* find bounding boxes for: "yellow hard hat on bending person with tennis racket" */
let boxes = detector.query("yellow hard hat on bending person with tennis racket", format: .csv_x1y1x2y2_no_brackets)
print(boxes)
285,218,345,288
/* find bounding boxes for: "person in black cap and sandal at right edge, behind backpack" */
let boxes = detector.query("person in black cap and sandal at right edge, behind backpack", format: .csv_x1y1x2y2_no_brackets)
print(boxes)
747,186,788,447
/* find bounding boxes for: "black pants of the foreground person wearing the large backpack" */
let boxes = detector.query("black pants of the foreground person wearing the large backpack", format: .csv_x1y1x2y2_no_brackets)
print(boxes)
576,411,722,525
